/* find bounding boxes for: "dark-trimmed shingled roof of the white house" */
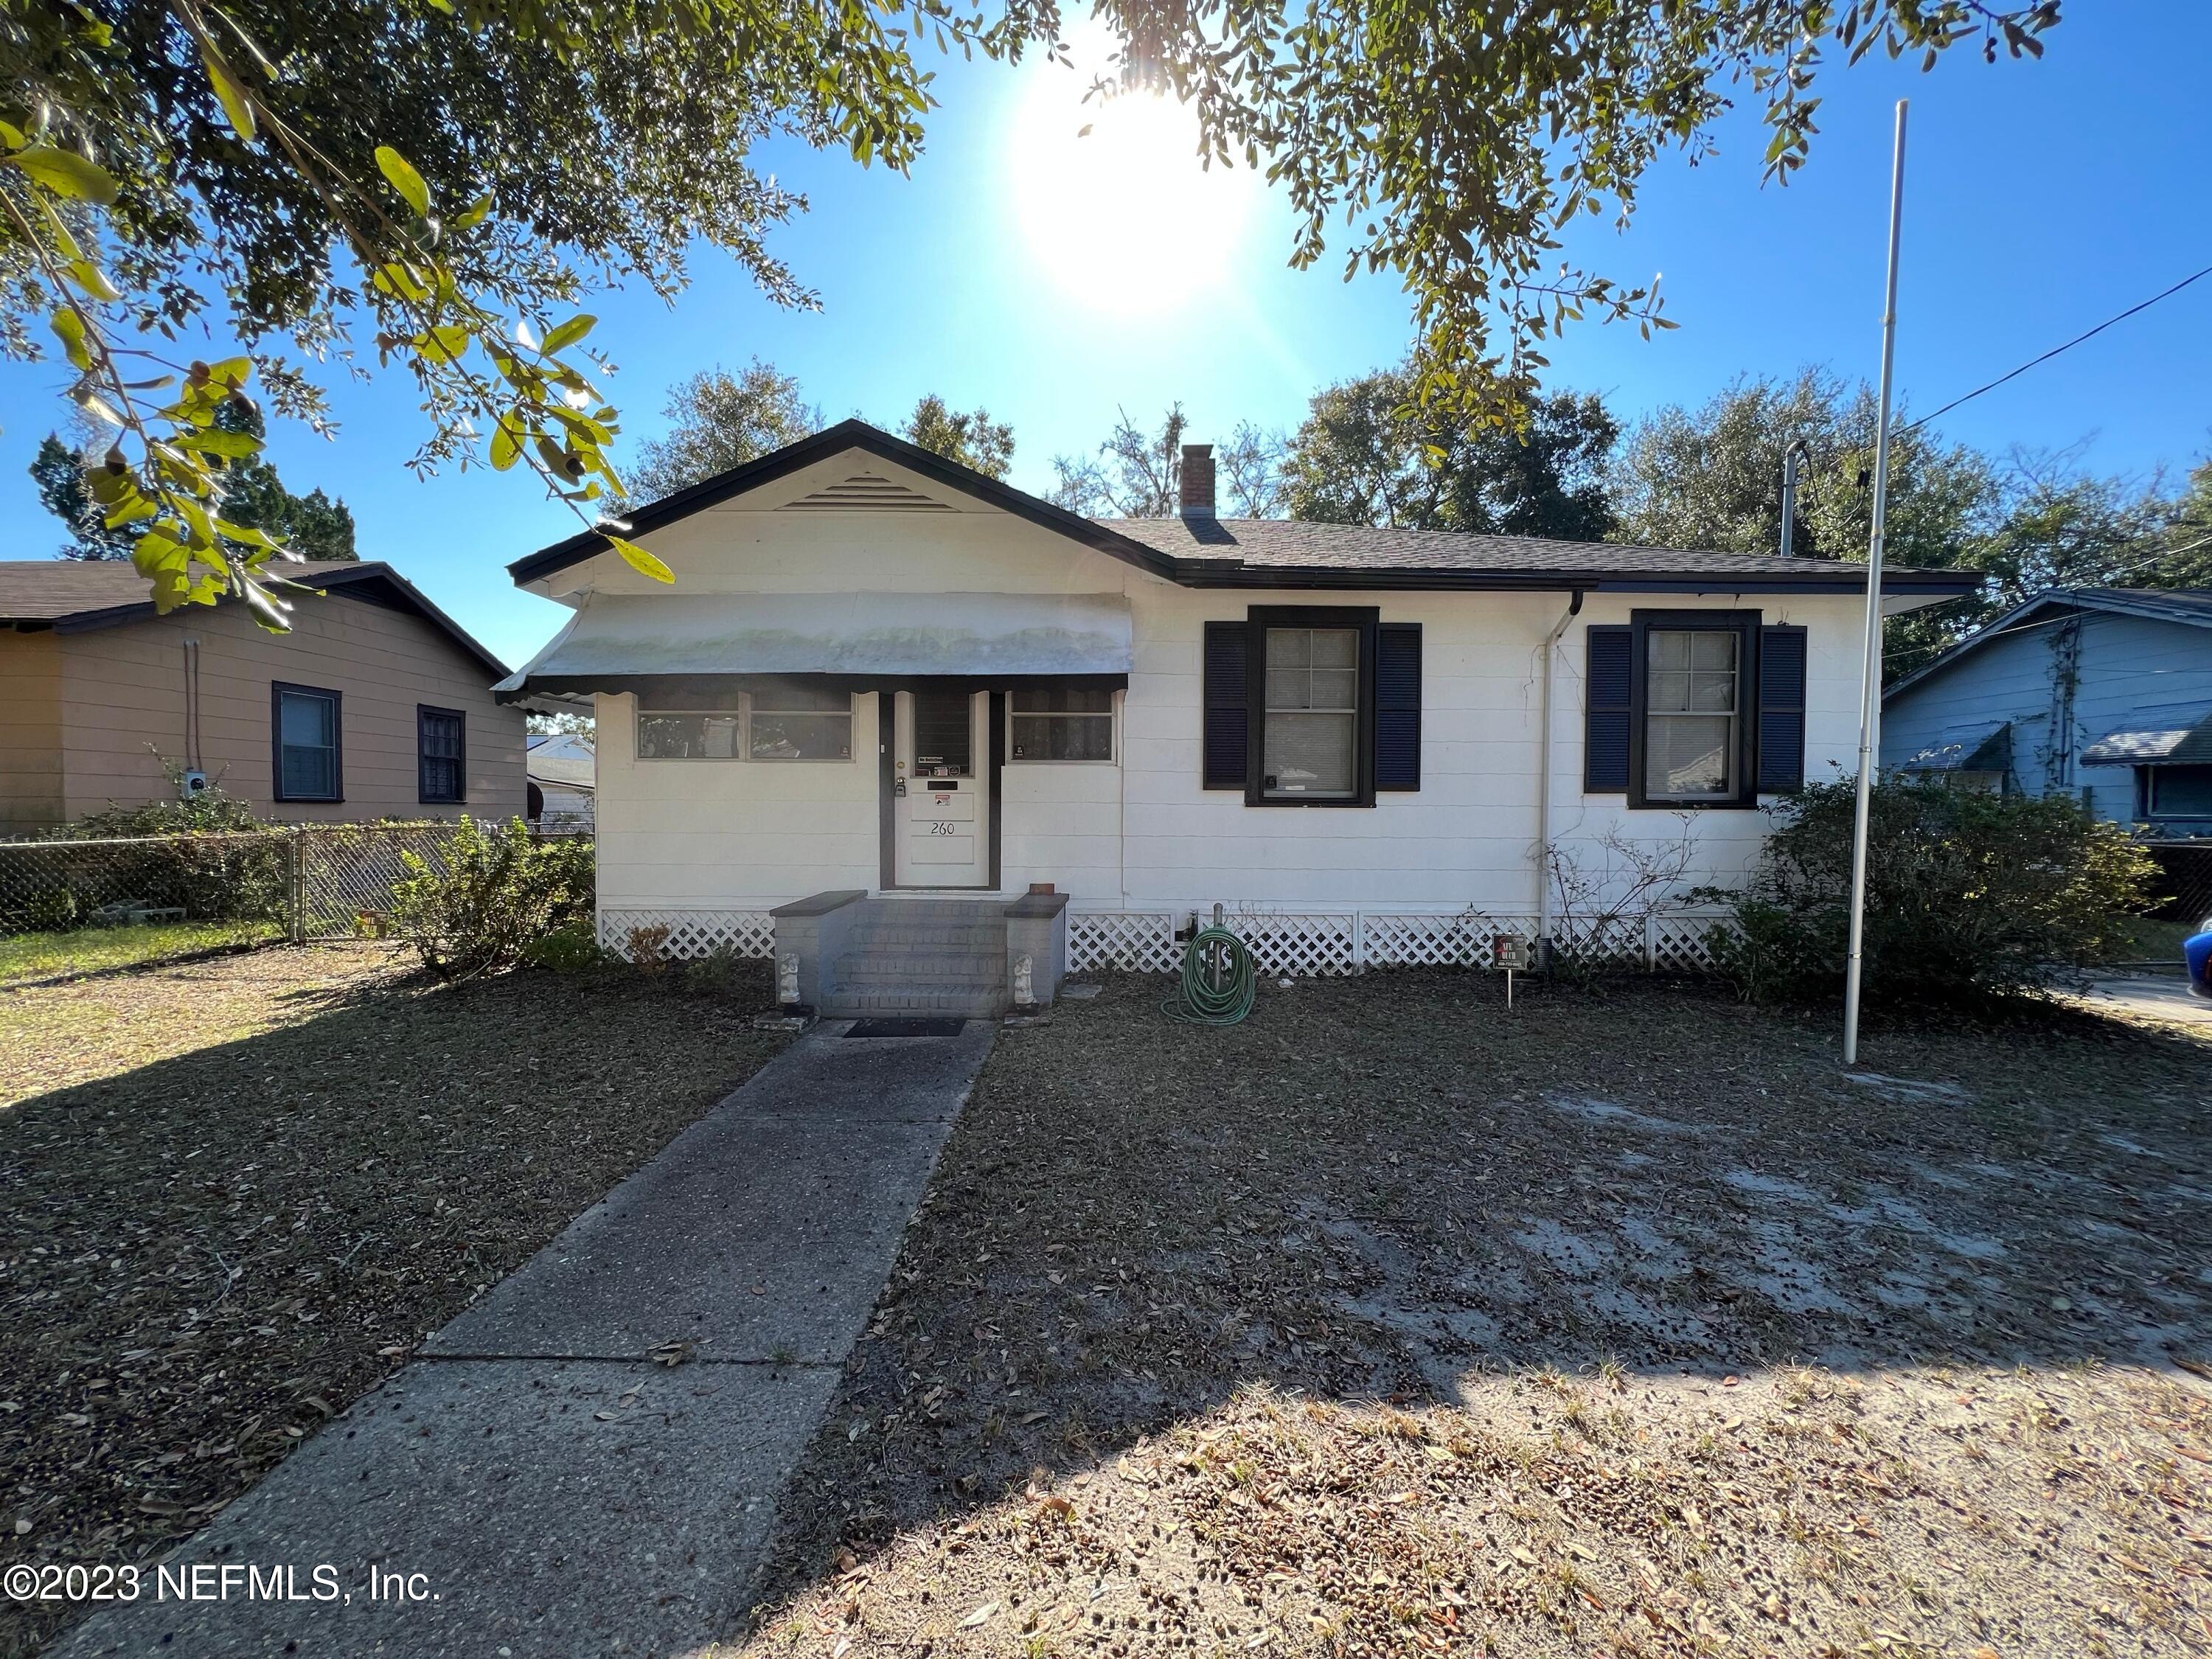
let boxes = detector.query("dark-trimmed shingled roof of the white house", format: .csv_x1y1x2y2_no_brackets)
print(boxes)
507,420,1982,602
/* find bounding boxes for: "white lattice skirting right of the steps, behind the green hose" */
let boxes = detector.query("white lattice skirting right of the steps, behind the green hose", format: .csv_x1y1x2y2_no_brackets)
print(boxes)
1068,902,1721,978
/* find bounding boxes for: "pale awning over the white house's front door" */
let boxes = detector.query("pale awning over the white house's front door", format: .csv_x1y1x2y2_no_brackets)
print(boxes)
495,586,1130,701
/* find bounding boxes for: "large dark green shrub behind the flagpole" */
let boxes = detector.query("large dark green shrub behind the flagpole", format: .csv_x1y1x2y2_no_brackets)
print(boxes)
1692,779,2157,1004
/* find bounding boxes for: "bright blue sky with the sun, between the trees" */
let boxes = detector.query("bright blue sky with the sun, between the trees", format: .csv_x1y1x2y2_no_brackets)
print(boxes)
0,0,2212,661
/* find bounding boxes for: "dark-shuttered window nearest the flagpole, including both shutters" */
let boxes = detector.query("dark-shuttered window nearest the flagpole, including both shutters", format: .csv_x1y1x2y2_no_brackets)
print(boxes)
1584,611,1805,807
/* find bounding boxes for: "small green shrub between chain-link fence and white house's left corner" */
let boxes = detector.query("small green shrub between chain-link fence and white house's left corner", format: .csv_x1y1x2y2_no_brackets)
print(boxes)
392,818,593,980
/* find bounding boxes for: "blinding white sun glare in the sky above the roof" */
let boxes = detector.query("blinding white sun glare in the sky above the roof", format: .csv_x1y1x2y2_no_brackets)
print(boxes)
1009,60,1261,316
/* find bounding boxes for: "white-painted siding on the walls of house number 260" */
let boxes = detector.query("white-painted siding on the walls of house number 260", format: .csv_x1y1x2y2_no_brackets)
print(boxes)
551,462,1860,914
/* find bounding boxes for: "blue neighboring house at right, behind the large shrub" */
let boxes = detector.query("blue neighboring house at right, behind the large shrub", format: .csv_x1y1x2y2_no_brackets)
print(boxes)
1882,588,2212,838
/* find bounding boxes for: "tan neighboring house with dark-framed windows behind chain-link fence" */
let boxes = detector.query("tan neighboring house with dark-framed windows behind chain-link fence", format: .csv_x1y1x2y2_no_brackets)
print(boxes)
0,560,524,836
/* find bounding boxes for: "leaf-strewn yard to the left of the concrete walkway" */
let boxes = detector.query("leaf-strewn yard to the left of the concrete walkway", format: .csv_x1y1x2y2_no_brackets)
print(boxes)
0,949,783,1652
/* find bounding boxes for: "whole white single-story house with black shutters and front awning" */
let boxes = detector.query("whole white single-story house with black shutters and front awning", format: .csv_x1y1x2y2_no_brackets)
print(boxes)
502,420,1973,1009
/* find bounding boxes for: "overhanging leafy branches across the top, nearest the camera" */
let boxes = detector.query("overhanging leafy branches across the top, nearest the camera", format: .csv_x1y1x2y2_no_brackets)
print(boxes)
0,0,2057,626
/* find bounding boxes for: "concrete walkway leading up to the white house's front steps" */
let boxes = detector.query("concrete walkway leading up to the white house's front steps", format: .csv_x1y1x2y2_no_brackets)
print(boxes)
58,1022,993,1659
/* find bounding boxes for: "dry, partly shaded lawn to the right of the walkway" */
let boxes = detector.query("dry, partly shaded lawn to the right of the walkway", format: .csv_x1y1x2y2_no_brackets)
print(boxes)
745,975,2212,1659
